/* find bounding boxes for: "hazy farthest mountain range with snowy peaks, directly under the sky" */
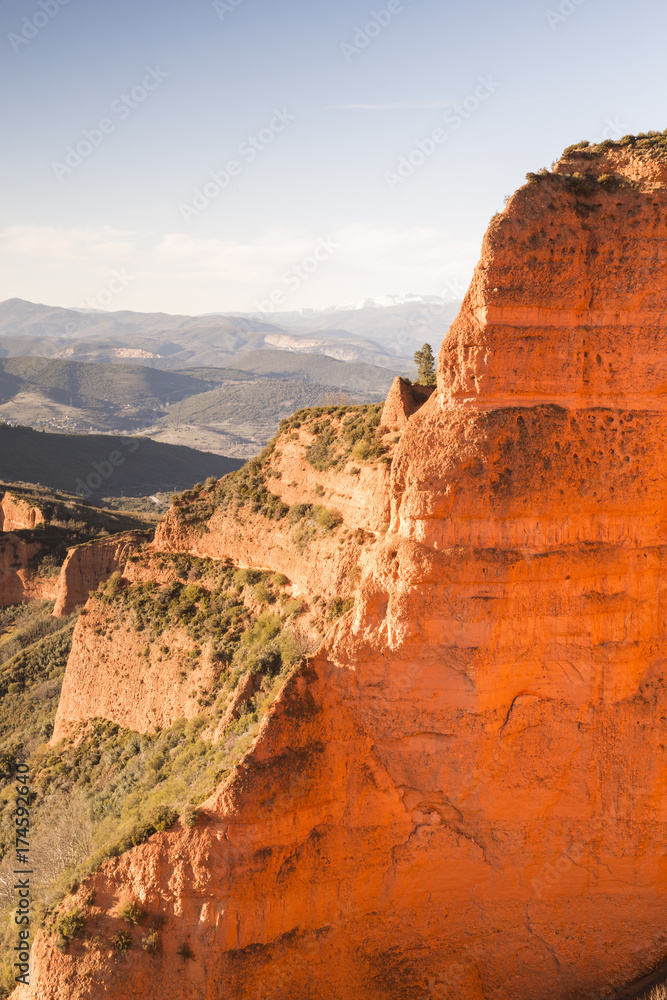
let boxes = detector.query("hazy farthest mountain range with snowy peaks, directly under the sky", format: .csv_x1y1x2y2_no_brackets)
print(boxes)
0,296,458,370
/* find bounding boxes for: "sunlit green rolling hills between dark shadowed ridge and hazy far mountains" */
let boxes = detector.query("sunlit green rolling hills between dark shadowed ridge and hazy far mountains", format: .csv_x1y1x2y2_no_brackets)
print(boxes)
0,351,393,458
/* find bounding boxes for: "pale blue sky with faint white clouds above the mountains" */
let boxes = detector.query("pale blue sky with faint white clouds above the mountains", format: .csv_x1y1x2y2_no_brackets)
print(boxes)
0,0,667,315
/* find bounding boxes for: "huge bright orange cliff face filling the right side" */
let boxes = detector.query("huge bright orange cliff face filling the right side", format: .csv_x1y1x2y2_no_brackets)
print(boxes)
24,151,667,1000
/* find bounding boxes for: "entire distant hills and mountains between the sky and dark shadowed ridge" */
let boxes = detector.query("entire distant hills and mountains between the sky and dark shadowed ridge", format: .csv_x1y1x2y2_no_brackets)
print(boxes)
0,296,458,458
